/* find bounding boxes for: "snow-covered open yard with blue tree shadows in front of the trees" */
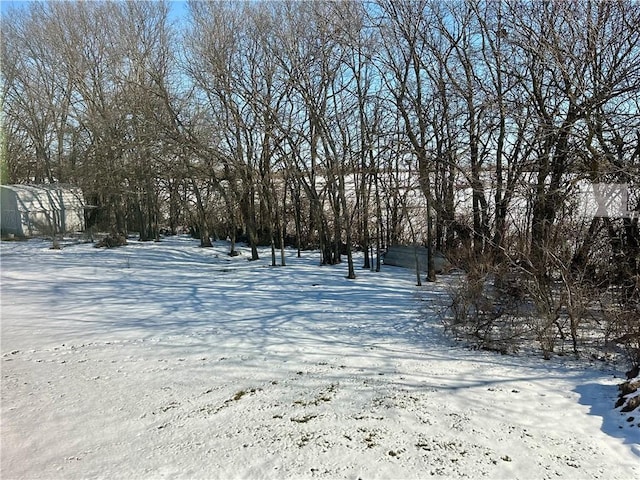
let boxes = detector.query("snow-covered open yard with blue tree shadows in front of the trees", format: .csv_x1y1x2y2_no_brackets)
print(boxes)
0,237,640,480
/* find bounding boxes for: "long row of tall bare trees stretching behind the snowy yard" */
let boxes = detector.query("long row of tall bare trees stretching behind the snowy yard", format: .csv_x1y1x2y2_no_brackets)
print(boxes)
1,0,640,356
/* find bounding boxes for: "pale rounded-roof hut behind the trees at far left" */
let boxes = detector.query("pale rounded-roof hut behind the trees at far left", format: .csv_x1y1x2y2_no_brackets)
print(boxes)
0,185,85,237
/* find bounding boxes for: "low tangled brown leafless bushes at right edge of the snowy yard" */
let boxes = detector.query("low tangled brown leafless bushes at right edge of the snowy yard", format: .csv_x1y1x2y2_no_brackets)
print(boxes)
445,251,640,366
